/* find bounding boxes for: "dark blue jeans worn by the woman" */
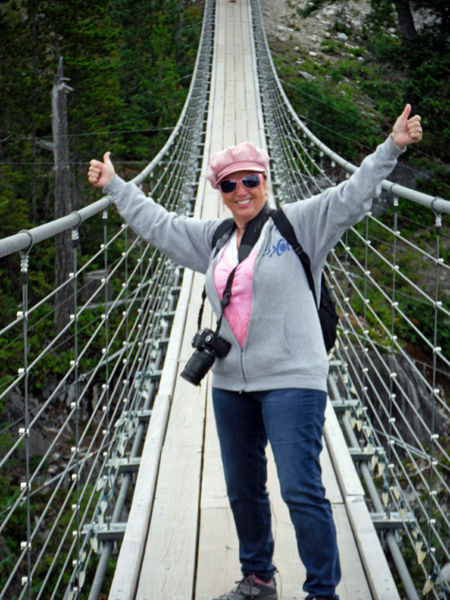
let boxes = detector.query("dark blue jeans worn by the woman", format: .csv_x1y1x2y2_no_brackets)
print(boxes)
213,388,341,600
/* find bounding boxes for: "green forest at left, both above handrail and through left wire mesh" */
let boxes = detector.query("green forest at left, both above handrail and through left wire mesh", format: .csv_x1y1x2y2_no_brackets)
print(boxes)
0,0,203,598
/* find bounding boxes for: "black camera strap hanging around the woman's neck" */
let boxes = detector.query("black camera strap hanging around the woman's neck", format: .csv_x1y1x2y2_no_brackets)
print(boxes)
198,203,271,337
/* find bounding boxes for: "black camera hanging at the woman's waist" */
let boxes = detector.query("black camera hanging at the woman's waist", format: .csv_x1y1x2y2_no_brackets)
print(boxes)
181,329,231,385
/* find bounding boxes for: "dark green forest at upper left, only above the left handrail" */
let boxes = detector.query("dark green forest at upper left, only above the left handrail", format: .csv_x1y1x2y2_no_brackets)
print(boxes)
0,0,201,233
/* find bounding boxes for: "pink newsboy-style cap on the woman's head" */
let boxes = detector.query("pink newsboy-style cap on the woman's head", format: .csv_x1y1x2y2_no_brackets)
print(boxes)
206,142,270,190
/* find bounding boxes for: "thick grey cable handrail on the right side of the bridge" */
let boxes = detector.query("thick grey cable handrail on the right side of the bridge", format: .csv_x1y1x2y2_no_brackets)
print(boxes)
255,0,450,214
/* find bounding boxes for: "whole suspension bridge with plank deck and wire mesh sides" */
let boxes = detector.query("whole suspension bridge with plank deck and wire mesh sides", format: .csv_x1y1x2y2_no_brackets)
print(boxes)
0,0,450,600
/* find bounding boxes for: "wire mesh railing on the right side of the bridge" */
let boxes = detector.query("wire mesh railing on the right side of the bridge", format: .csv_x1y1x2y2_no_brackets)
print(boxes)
252,0,450,598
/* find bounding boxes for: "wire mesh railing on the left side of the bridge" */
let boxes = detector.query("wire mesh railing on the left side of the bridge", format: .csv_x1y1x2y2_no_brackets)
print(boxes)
0,2,214,600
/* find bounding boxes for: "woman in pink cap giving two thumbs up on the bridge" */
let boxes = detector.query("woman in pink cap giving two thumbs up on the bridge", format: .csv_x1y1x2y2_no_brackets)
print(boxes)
88,104,422,600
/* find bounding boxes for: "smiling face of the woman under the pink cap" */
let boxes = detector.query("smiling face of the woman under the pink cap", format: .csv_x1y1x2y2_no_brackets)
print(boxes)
219,171,267,229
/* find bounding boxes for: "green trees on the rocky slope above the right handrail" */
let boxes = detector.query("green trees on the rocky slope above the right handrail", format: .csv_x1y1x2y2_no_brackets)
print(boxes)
288,0,450,198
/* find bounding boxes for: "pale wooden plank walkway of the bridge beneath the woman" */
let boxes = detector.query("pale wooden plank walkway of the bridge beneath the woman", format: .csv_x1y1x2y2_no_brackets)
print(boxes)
109,0,399,600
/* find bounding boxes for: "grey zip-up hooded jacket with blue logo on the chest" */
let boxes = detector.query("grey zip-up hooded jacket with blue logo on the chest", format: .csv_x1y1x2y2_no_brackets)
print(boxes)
103,137,402,391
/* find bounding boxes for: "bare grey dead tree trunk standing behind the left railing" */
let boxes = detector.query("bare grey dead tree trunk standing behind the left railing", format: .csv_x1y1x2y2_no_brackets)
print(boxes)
52,57,74,341
